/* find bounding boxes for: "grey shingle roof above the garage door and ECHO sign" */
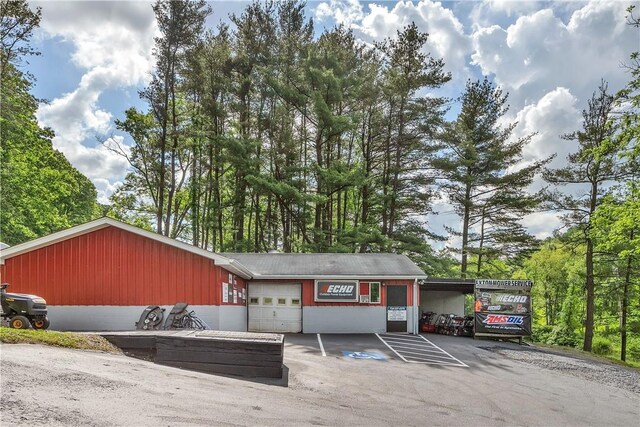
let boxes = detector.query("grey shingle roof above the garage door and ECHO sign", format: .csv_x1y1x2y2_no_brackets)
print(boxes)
221,253,426,279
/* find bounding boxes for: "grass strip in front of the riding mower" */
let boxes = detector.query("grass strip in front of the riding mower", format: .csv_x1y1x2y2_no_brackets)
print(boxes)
0,326,120,353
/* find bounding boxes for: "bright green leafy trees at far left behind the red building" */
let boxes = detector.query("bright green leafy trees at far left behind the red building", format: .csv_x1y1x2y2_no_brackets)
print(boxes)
0,2,99,245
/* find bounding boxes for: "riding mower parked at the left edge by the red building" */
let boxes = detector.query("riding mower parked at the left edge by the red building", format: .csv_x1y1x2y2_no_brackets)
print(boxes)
0,283,49,329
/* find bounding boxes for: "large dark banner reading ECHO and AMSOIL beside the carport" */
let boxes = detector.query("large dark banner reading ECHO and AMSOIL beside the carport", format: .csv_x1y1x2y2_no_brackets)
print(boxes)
474,280,532,336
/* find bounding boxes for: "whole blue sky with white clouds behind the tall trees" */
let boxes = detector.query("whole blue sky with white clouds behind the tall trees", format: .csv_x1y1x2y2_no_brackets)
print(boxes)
28,0,640,241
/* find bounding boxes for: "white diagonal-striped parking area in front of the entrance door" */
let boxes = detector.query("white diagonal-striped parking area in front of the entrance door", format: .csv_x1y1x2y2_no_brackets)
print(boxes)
376,334,468,368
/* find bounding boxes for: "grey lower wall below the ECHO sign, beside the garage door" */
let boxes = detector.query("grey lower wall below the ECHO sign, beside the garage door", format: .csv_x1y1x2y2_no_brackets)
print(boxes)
302,306,387,334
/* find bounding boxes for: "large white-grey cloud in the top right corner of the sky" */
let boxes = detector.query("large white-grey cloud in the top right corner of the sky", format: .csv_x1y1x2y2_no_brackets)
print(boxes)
471,1,639,108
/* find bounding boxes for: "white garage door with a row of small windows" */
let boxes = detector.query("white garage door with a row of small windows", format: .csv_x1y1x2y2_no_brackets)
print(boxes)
249,283,302,333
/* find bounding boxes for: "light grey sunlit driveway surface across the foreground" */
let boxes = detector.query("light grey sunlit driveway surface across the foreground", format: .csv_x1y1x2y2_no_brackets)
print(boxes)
0,337,640,426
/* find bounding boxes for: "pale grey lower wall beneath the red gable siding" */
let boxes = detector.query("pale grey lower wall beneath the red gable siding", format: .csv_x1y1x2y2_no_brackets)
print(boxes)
47,305,221,331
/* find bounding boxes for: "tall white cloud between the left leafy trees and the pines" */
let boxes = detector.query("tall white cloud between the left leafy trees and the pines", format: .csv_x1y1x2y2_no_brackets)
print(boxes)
36,1,156,202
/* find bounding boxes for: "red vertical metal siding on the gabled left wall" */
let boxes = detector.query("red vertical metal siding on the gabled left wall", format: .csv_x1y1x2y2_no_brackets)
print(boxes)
0,227,231,305
